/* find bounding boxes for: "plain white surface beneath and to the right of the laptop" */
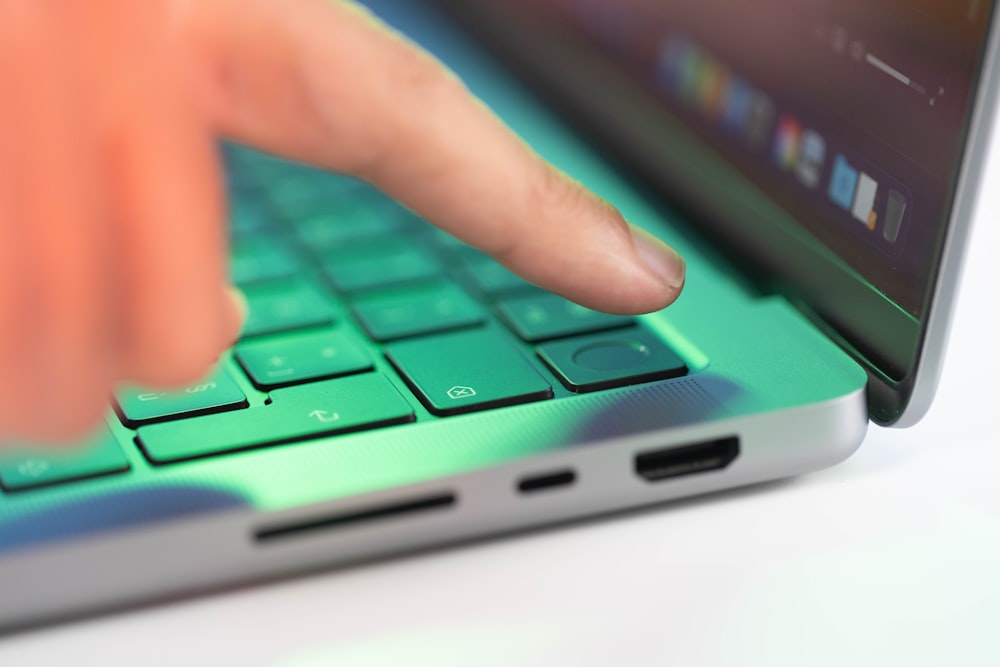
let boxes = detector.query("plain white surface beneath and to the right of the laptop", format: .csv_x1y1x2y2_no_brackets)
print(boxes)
0,117,1000,667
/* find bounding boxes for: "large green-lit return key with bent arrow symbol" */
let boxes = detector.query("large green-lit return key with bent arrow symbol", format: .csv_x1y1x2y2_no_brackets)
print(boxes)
137,373,414,464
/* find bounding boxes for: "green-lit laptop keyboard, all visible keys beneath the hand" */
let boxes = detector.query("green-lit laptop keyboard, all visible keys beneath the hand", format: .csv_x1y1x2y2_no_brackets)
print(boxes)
0,145,687,492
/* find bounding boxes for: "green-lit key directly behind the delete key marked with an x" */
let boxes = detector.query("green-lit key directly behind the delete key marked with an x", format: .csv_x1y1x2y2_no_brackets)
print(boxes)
353,282,483,341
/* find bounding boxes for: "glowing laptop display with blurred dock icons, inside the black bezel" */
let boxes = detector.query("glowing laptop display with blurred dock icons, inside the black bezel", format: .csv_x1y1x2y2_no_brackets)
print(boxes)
540,0,990,318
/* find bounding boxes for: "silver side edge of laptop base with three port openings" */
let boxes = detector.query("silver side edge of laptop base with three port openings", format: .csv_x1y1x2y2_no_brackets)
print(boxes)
0,389,868,631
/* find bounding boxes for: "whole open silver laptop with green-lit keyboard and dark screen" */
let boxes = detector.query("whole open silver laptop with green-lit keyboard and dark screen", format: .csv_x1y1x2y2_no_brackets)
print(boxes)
0,0,997,630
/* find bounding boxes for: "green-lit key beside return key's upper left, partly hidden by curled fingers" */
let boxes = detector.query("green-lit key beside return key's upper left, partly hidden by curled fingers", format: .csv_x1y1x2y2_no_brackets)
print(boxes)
115,368,248,428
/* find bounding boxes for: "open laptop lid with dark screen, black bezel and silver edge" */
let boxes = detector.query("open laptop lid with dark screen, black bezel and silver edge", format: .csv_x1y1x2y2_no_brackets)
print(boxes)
441,0,996,426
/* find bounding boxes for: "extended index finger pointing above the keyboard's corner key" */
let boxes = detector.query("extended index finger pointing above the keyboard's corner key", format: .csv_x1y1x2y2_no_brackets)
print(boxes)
176,0,684,313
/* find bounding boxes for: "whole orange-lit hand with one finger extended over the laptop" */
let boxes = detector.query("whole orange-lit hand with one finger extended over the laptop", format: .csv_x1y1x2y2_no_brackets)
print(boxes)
0,0,684,442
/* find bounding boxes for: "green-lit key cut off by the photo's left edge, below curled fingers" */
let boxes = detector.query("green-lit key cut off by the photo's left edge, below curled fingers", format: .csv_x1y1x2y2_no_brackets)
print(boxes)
0,426,129,491
